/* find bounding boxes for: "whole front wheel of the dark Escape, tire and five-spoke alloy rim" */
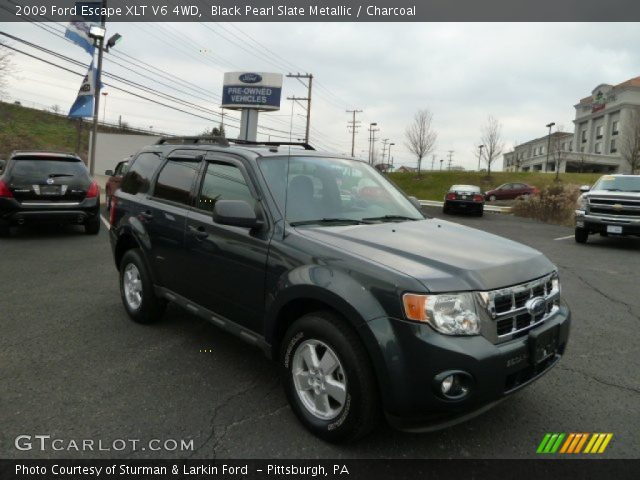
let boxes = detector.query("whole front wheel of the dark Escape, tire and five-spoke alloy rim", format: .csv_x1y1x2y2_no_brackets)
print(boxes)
280,311,380,443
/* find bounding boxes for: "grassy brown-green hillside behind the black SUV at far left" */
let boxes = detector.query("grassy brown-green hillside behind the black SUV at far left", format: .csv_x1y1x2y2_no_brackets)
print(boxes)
0,102,151,160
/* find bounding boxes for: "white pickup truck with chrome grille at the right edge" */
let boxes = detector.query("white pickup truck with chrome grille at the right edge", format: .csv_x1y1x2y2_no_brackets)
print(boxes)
575,175,640,243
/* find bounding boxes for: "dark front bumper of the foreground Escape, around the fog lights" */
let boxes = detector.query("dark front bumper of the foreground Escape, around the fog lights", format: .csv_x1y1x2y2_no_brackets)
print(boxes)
361,305,571,431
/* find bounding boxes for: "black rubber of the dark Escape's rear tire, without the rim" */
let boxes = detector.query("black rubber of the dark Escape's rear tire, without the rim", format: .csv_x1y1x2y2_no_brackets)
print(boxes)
119,248,167,323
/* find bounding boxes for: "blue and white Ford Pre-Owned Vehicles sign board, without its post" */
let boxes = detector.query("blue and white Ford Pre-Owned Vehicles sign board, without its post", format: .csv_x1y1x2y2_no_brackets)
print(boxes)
222,72,282,110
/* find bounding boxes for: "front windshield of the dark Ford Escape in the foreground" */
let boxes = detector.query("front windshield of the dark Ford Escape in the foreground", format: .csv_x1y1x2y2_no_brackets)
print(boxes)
258,156,424,225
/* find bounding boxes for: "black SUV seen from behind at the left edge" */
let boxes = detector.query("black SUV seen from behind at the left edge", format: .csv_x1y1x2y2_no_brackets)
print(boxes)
0,151,100,235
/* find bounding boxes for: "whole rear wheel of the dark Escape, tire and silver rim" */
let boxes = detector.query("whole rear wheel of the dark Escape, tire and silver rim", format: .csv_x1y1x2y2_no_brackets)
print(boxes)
119,248,167,323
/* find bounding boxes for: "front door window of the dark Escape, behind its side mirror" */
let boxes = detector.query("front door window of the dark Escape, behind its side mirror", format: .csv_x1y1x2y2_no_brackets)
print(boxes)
197,162,256,212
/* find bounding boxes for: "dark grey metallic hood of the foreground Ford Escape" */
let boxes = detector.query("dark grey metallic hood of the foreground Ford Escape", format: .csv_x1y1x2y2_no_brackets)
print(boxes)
297,219,555,292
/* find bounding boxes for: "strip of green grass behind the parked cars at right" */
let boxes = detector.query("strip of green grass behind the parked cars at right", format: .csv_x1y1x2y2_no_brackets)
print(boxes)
389,171,601,200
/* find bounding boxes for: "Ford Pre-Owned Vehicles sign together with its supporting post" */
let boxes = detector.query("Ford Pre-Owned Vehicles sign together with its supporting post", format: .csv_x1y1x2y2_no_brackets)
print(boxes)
221,72,282,142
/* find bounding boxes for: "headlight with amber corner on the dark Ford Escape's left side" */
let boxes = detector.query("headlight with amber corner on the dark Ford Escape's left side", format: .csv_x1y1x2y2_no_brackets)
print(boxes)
402,293,480,335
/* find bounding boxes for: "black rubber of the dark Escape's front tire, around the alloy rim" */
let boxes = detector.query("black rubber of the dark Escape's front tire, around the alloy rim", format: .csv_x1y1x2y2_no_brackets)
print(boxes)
280,311,380,443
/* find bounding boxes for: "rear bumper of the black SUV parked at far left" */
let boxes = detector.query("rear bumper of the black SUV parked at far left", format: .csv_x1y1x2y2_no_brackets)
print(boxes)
0,198,100,225
